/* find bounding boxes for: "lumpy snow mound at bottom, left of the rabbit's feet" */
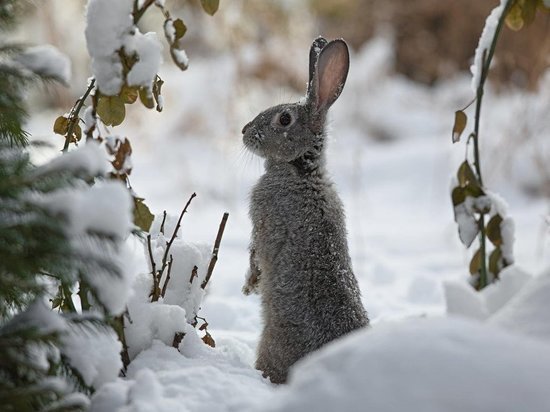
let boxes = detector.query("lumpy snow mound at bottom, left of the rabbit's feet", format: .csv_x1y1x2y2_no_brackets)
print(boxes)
91,340,272,412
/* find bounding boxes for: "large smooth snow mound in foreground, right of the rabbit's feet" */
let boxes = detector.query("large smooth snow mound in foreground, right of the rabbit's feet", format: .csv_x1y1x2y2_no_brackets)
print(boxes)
264,318,550,412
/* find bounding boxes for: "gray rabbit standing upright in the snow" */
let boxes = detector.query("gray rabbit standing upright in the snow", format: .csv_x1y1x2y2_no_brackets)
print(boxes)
243,37,369,383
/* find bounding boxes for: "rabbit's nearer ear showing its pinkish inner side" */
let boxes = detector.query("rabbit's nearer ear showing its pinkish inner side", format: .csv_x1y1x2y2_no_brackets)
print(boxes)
307,39,349,117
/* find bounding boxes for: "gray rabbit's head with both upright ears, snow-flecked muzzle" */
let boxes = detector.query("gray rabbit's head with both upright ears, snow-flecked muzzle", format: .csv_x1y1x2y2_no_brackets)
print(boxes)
242,37,349,167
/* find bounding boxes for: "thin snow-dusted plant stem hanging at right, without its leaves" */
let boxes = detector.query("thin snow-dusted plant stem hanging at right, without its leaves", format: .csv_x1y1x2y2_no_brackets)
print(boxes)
473,0,513,289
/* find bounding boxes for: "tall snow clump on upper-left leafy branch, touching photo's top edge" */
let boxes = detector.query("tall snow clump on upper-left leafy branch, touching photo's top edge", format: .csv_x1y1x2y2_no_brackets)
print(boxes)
85,0,134,96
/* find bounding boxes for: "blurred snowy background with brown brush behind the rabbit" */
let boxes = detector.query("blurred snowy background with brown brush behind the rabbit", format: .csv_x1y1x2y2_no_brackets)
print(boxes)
10,0,550,330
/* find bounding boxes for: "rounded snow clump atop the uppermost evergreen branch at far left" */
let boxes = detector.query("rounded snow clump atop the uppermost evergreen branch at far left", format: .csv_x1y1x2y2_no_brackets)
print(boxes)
17,44,71,85
